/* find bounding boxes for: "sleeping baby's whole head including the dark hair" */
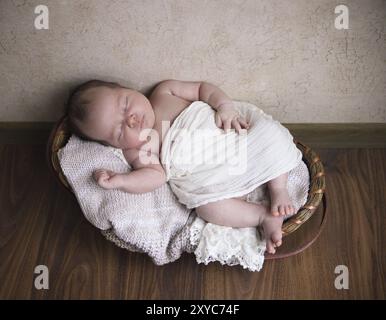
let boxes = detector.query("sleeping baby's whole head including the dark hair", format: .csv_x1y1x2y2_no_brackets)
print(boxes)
67,80,155,149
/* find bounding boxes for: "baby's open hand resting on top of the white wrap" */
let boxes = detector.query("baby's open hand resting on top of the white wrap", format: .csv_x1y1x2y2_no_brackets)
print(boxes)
215,102,249,133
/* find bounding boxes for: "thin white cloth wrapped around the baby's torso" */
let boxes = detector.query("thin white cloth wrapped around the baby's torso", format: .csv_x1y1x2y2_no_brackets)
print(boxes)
160,101,302,209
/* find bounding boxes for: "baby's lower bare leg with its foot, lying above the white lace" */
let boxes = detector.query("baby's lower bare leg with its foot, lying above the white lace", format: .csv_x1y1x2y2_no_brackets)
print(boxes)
196,198,283,253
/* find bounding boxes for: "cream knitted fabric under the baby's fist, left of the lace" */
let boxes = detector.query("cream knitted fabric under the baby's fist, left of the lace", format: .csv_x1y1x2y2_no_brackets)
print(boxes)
58,136,190,264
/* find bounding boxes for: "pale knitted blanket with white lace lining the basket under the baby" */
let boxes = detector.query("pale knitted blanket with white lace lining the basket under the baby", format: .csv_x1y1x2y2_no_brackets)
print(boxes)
58,107,309,271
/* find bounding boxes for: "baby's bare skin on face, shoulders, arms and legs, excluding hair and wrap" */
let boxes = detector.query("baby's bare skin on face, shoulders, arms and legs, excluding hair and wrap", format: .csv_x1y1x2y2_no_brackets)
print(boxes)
82,80,294,253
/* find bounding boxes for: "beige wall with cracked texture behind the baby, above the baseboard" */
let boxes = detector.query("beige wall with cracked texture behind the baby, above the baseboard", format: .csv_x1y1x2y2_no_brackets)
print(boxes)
0,0,386,123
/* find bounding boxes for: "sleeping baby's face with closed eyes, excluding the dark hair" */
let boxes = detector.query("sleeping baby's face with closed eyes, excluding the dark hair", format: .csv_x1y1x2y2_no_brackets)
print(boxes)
82,87,155,149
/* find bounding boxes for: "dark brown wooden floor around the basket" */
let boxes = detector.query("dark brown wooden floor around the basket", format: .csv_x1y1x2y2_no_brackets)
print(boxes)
0,145,386,299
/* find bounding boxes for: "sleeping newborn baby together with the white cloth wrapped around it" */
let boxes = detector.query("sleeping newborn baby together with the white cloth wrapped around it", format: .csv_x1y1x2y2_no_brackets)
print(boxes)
68,80,302,253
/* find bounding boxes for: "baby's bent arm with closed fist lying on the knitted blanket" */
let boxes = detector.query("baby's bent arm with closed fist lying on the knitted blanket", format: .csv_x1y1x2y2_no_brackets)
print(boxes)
93,150,166,193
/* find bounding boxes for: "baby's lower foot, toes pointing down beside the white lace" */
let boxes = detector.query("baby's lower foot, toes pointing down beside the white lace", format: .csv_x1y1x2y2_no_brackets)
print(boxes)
261,213,283,254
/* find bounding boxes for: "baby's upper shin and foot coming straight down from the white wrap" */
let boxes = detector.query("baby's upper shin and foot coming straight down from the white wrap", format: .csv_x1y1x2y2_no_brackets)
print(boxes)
268,173,295,216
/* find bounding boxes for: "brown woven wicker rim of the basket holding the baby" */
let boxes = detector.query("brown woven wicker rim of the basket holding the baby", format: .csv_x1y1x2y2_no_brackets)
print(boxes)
47,116,326,236
